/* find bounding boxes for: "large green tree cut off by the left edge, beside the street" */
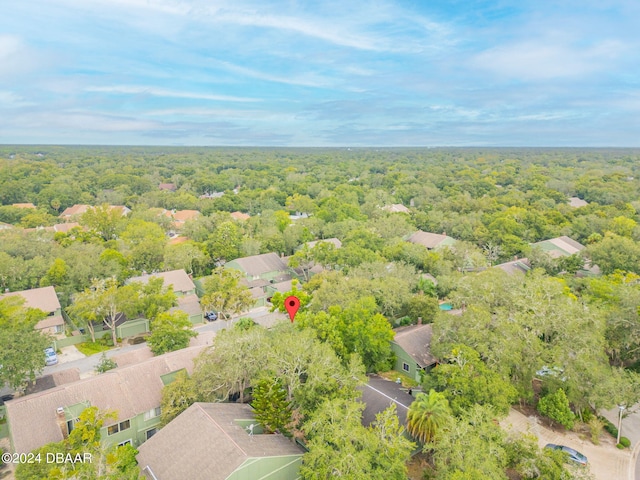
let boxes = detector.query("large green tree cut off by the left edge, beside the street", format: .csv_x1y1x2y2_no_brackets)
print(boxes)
0,295,51,389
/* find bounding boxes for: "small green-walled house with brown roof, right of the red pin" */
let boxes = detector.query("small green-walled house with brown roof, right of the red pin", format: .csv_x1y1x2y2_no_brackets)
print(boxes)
391,323,437,382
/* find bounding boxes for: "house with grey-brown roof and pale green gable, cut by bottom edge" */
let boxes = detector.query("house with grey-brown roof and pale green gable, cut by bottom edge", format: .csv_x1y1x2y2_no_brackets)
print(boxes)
137,403,304,480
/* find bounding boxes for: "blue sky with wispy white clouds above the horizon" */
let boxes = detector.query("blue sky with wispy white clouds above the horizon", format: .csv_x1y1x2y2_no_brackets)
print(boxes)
0,0,640,147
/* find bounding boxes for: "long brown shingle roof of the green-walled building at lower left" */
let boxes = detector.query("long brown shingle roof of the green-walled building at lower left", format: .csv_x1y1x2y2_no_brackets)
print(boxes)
6,347,203,452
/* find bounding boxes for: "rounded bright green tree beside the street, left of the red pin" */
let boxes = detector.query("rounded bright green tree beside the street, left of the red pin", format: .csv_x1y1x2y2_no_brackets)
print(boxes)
147,311,198,355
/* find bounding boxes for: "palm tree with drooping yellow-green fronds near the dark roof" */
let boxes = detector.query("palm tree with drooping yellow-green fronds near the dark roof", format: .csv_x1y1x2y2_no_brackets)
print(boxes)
407,390,451,443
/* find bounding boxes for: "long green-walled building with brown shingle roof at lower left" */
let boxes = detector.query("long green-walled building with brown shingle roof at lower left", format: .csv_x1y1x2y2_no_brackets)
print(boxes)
6,346,205,453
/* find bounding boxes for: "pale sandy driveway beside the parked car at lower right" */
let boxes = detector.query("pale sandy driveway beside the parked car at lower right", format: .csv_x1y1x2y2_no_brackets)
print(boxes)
501,409,634,480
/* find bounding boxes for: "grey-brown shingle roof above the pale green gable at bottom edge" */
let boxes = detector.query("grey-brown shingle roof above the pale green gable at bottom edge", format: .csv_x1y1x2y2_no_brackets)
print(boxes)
137,403,303,480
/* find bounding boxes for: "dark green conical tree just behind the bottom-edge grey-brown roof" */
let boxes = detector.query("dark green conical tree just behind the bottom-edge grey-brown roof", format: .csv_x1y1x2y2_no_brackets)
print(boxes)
251,378,292,435
